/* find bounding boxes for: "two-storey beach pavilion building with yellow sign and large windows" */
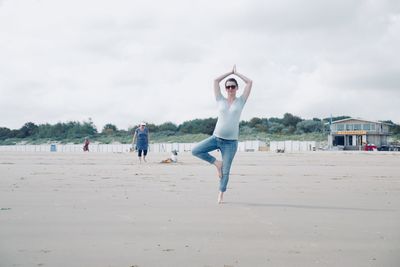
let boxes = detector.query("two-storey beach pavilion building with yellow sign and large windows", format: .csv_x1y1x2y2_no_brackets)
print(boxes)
328,118,389,150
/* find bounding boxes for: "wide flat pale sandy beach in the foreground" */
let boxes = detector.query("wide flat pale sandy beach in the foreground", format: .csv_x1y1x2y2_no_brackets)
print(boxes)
0,151,400,267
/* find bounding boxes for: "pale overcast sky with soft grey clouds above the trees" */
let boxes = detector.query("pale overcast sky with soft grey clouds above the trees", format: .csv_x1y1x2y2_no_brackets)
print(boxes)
0,0,400,130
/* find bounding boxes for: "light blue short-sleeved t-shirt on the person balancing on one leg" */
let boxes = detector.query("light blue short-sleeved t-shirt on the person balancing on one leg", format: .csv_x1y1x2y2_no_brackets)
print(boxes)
213,95,246,140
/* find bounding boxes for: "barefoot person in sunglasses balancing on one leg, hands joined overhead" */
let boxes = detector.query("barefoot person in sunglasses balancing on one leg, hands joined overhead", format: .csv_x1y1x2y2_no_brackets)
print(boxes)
192,65,253,203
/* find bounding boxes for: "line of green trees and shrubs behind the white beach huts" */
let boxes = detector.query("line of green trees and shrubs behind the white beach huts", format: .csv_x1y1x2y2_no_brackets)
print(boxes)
0,113,400,141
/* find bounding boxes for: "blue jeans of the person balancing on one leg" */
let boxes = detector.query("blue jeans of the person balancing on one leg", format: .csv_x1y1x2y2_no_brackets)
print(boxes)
192,136,237,192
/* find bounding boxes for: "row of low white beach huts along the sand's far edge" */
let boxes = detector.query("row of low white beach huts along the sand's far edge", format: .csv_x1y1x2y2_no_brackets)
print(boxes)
0,140,320,153
